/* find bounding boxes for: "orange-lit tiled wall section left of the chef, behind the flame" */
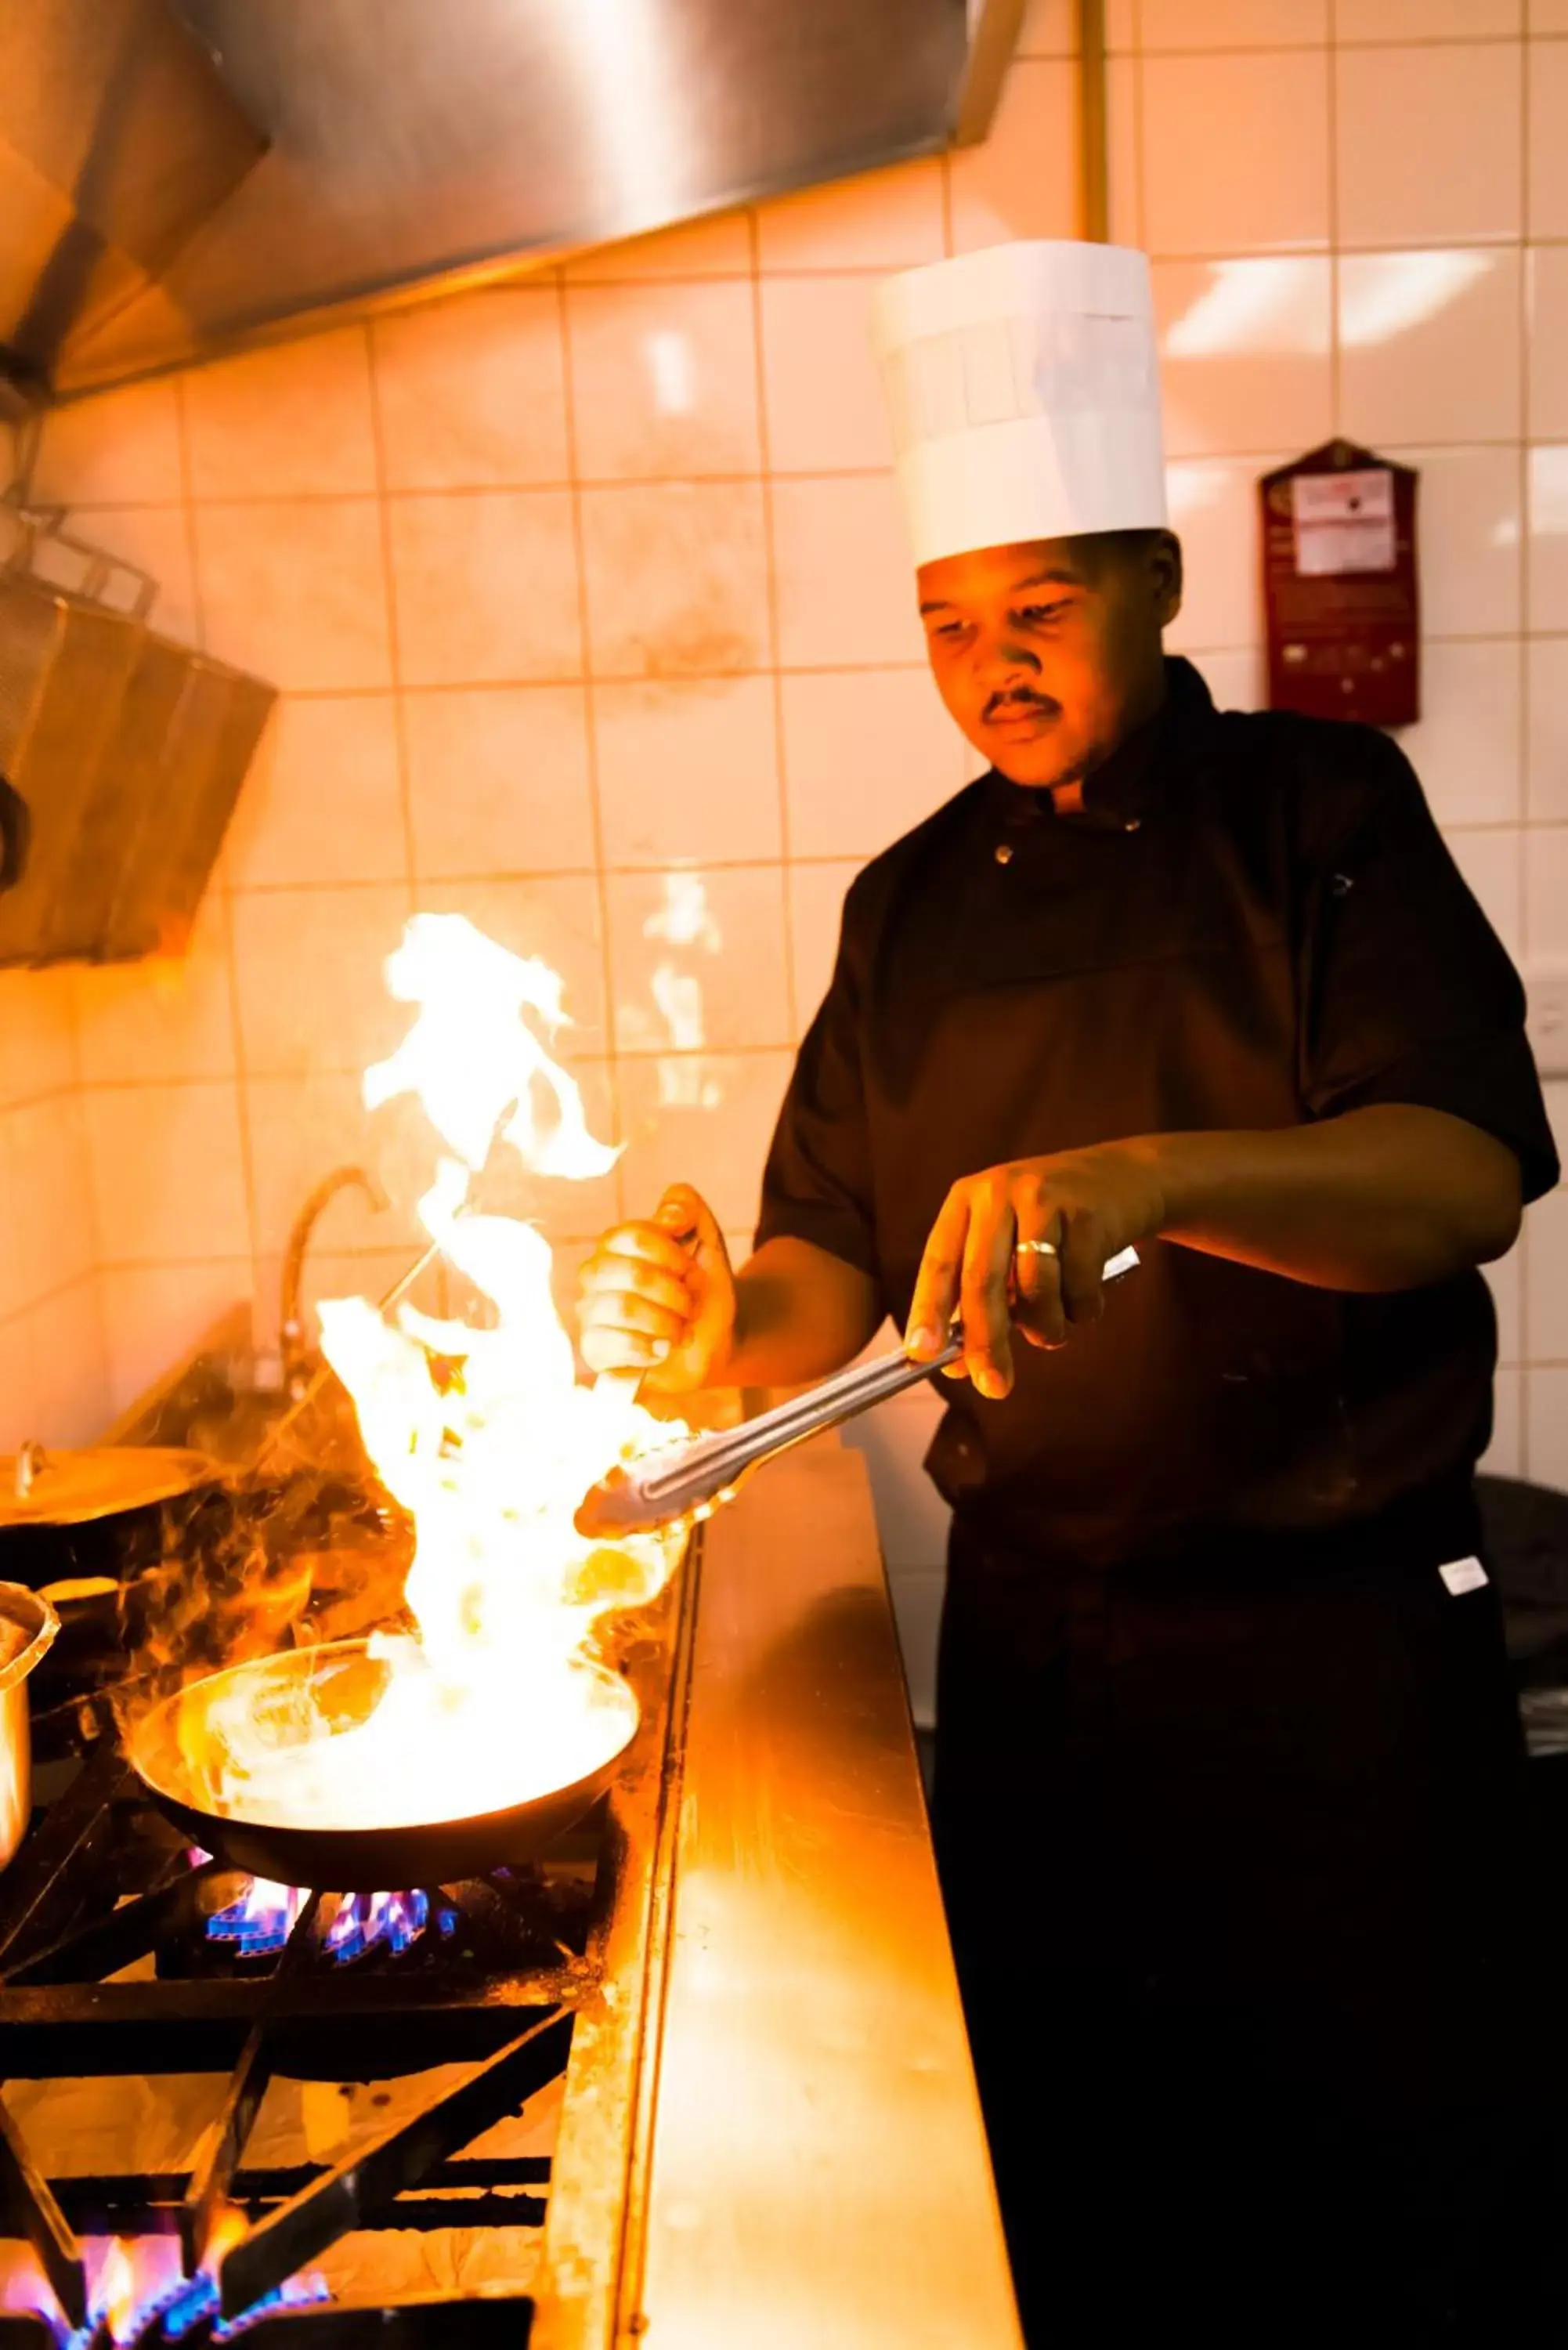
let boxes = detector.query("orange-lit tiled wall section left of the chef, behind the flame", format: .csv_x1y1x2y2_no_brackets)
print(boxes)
23,106,1072,1466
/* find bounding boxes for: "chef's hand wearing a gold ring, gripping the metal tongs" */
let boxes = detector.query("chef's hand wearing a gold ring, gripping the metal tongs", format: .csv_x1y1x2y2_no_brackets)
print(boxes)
905,1142,1166,1396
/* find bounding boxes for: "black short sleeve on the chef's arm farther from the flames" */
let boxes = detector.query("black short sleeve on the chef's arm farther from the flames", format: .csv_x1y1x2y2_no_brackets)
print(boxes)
1300,733,1559,1201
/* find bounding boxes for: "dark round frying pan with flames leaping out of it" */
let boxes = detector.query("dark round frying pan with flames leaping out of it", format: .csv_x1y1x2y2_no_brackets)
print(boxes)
127,1640,637,1894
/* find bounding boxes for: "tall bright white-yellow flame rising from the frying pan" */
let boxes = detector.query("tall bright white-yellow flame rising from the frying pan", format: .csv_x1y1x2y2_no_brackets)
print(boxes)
201,914,679,1828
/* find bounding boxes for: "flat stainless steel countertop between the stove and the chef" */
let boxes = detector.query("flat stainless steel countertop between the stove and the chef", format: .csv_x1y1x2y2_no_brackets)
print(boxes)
623,1438,1021,2350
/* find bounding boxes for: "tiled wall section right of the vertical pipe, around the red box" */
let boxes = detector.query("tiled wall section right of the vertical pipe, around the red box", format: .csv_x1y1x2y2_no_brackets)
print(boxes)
1110,0,1568,1579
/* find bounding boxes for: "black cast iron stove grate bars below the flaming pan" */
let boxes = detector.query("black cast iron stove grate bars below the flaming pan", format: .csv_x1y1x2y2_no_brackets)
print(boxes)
0,1748,616,2350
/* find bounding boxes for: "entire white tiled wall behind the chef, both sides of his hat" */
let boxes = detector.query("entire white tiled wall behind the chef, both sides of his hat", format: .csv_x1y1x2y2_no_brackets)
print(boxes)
0,0,1568,1708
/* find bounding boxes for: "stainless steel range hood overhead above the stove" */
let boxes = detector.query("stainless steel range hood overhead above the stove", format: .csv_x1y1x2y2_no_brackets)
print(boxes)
0,0,1023,397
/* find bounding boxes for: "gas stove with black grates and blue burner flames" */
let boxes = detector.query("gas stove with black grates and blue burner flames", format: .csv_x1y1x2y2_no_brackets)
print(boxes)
0,1553,698,2350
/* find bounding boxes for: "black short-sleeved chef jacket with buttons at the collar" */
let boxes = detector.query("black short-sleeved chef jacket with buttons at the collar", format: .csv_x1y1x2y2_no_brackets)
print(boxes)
757,660,1556,1567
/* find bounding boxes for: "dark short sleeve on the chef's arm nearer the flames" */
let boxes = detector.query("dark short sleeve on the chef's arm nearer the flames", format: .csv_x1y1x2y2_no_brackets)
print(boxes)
757,891,880,1281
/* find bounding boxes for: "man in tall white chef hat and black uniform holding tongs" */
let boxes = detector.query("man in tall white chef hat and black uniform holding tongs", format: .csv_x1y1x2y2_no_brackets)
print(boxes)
580,244,1559,2345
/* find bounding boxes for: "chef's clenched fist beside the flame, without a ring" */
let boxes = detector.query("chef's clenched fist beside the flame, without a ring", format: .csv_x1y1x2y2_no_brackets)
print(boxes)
578,1182,735,1396
